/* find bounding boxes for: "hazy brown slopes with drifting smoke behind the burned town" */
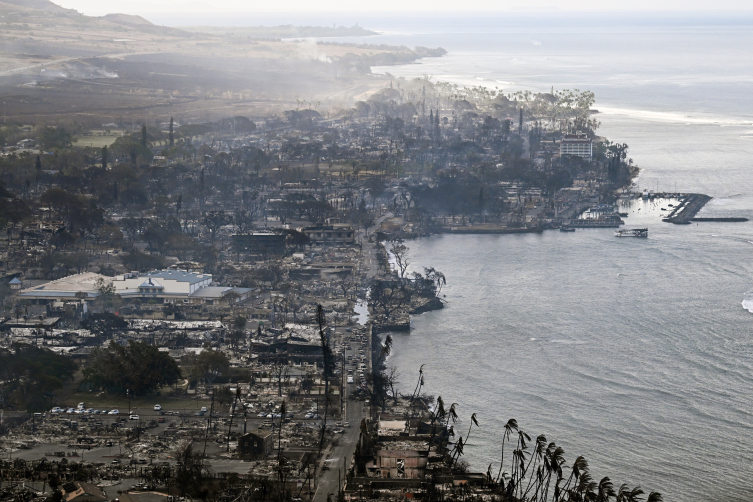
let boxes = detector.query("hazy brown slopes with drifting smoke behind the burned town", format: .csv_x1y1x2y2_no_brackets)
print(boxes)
0,0,441,125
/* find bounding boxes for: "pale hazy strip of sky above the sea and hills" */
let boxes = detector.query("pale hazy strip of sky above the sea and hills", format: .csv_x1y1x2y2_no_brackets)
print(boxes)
53,0,753,22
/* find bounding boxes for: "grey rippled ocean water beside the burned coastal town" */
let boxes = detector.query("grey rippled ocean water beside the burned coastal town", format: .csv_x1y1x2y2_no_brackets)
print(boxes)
356,15,753,502
